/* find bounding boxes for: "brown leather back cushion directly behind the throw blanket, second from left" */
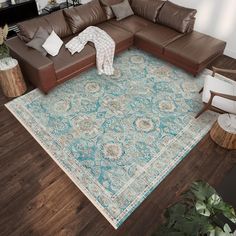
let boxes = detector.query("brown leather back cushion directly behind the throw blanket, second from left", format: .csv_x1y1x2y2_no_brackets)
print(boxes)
64,0,106,34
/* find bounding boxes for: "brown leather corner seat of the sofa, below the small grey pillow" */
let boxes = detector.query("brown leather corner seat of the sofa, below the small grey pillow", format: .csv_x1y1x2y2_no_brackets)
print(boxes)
108,15,152,33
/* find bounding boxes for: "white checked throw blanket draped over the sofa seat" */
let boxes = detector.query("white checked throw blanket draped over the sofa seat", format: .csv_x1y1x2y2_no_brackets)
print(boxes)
65,26,115,75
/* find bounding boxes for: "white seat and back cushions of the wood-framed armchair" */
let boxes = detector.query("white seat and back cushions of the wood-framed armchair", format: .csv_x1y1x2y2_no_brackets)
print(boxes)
202,75,236,114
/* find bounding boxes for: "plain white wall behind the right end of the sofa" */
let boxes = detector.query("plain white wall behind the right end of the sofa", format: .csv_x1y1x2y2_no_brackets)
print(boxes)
171,0,236,58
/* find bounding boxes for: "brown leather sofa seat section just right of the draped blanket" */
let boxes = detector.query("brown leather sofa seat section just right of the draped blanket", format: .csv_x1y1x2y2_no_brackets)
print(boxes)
91,22,133,52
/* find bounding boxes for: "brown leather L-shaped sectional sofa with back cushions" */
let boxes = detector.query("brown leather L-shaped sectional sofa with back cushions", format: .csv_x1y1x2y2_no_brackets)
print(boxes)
7,0,226,93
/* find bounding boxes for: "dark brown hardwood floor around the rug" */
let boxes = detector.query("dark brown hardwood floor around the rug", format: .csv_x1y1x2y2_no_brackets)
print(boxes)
0,56,236,236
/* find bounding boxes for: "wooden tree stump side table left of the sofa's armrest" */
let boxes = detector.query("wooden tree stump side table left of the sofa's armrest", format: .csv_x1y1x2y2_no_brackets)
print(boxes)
0,57,27,97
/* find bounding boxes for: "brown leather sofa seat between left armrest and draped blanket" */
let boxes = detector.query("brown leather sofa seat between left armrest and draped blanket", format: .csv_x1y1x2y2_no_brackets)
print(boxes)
48,35,96,80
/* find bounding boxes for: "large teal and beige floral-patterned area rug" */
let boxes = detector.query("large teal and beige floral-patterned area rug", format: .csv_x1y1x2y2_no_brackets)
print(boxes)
6,49,215,228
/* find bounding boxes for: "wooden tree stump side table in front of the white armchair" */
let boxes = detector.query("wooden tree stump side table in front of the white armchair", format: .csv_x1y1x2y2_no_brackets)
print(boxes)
210,114,236,149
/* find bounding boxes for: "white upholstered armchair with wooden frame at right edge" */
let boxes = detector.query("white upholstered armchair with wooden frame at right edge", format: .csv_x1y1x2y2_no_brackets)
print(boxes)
195,67,236,118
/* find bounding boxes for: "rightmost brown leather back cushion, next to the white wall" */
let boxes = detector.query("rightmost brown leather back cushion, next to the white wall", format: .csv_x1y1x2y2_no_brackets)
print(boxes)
157,1,197,33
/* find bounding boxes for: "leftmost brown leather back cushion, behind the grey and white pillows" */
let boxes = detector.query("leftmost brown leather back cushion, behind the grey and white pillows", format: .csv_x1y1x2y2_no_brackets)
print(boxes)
17,10,71,42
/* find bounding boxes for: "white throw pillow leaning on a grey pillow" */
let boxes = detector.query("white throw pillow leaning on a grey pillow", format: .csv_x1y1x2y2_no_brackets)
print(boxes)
42,30,63,57
